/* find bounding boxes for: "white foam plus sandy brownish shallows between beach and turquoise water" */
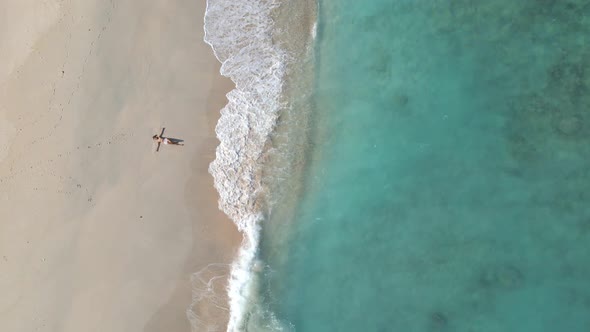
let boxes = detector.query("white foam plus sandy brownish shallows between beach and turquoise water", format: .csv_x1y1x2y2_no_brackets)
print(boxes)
205,0,317,331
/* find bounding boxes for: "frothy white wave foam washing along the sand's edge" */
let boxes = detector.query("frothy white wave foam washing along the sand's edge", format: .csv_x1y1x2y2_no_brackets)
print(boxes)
198,0,287,332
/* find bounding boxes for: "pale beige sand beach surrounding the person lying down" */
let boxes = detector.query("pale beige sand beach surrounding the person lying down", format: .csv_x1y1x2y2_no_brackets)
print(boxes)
0,0,241,332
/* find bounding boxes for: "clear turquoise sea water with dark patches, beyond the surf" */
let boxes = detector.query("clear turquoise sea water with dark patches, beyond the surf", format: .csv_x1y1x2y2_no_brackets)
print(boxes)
257,0,590,332
